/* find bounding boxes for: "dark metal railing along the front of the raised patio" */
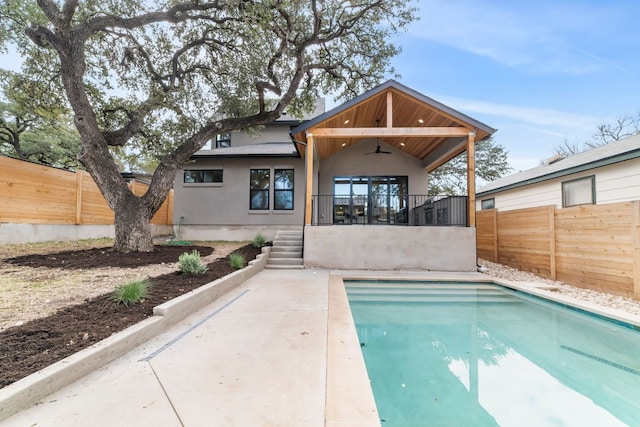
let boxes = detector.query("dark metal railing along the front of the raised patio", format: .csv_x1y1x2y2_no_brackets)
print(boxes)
311,194,467,227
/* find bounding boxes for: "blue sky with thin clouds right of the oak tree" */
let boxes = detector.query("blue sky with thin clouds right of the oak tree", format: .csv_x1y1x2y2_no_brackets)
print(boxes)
393,0,640,171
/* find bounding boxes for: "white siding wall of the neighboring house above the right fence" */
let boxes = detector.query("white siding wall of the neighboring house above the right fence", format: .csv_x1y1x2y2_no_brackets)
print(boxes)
476,159,640,211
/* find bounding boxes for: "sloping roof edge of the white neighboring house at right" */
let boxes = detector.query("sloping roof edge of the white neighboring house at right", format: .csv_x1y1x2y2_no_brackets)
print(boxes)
476,134,640,196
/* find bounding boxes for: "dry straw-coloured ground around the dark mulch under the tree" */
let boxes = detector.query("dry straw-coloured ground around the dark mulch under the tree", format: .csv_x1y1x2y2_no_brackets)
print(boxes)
0,239,247,331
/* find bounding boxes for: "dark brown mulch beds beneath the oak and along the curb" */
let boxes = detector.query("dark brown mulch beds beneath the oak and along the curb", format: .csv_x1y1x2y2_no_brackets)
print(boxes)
0,244,261,388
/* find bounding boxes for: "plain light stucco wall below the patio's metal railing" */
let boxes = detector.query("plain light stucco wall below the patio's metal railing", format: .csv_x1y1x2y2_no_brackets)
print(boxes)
304,225,476,271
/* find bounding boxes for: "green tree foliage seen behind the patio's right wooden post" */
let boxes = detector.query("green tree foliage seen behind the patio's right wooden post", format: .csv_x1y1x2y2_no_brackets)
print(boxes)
428,138,511,196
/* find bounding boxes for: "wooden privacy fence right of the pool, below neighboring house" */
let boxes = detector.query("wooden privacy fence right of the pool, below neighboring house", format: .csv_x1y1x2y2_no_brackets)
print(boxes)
476,201,640,300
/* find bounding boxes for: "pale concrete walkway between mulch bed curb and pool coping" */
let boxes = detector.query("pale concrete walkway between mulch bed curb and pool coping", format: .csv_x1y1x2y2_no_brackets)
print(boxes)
0,270,336,427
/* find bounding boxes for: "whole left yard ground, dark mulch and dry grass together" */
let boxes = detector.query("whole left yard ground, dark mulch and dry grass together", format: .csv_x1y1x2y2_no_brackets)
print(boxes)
0,239,261,388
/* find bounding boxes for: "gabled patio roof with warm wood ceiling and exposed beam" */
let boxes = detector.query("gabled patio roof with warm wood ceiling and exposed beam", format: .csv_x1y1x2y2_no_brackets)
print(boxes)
292,80,495,171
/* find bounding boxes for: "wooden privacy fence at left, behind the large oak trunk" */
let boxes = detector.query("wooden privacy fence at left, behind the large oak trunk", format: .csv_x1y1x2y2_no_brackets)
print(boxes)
0,156,173,225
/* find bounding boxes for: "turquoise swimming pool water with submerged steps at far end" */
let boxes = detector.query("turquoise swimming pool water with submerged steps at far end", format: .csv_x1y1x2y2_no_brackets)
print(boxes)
345,280,640,427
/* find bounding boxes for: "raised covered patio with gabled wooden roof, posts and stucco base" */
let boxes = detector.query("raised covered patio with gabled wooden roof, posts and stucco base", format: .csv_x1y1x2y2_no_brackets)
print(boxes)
291,80,495,271
